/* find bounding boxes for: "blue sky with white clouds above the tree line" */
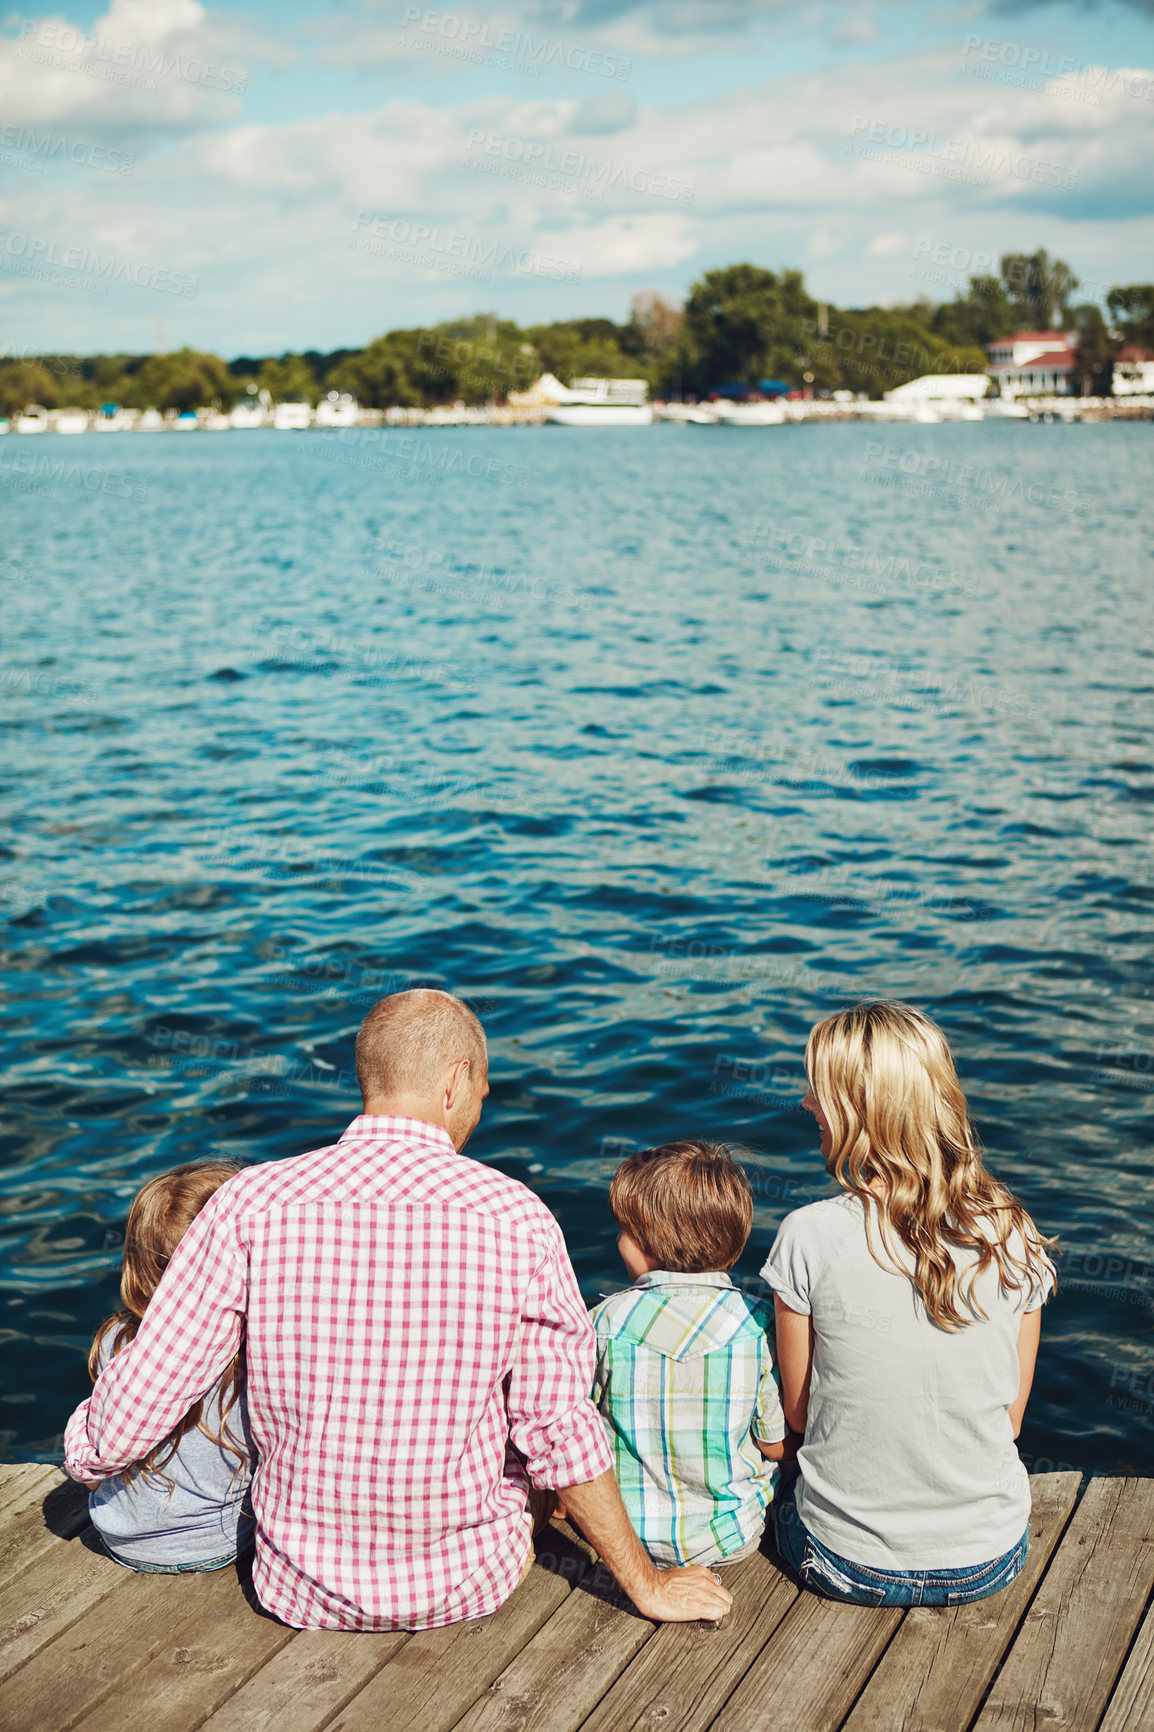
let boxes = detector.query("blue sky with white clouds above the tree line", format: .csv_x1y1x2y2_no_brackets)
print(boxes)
0,0,1154,357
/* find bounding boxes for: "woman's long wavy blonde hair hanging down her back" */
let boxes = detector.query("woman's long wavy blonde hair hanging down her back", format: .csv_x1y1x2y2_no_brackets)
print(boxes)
806,1001,1054,1330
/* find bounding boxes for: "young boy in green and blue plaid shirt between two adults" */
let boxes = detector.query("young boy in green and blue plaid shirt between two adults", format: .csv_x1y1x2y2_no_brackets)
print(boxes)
593,1143,790,1564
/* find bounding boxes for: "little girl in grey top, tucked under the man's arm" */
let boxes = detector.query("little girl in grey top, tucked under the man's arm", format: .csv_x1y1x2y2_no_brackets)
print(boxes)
88,1160,251,1574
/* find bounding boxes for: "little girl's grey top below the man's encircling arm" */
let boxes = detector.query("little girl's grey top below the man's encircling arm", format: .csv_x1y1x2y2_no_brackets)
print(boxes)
88,1330,253,1564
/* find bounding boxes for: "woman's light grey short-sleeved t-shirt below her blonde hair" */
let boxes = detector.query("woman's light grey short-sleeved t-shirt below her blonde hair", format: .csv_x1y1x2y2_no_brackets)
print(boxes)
762,1193,1054,1569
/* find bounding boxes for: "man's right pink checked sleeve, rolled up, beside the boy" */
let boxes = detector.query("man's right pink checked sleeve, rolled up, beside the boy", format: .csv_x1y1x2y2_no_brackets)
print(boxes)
506,1228,613,1491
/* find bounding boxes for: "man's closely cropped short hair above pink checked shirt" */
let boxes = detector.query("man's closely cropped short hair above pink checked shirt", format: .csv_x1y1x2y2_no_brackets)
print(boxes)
357,987,489,1102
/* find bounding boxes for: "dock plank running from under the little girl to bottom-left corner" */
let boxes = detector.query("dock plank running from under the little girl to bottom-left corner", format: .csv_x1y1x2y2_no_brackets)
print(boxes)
0,1569,236,1732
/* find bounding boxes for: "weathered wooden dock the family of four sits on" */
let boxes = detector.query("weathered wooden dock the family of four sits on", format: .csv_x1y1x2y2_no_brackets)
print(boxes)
0,1465,1154,1732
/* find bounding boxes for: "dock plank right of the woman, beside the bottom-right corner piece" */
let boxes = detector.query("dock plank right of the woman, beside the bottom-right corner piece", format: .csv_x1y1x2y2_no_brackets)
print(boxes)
977,1479,1154,1732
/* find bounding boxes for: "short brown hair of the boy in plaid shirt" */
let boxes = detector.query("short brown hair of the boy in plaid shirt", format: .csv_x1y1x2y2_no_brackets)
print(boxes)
610,1141,754,1275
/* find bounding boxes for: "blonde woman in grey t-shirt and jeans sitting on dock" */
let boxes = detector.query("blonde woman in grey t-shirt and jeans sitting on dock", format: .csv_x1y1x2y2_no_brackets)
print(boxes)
762,1003,1054,1606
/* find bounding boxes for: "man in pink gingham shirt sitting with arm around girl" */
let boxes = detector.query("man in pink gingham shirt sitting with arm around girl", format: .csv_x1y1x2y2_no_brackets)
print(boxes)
64,991,731,1630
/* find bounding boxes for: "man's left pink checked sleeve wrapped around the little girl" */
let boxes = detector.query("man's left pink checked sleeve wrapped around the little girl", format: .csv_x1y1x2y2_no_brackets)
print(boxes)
64,1188,248,1481
